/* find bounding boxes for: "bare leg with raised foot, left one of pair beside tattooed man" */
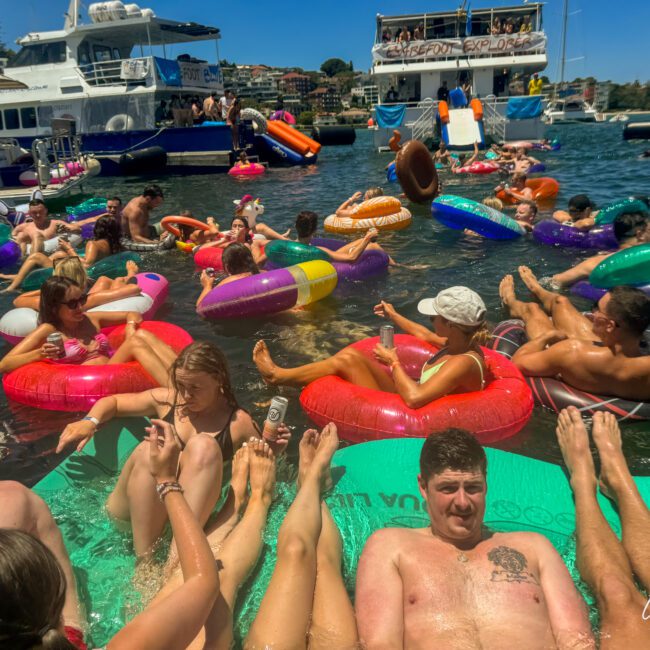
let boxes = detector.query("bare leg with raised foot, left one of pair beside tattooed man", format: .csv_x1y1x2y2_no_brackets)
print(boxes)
244,424,338,650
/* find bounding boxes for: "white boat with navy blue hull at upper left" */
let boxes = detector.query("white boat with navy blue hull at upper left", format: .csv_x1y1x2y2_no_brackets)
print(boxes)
0,0,253,174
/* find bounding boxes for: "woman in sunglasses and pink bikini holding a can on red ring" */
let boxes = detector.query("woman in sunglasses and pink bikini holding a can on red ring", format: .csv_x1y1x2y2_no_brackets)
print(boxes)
0,277,176,386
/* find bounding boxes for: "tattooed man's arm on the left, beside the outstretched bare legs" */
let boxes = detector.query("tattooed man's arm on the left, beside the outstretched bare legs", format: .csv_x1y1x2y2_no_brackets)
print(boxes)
355,529,404,650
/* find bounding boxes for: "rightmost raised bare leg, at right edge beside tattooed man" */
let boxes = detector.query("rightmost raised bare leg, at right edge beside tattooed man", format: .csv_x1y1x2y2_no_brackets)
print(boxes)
592,413,650,591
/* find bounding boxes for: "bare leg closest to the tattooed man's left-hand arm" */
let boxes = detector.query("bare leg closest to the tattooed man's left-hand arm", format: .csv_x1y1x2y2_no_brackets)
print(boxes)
309,502,359,650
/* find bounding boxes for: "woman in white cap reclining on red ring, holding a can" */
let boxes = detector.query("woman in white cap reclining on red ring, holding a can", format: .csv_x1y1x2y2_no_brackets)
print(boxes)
253,287,489,408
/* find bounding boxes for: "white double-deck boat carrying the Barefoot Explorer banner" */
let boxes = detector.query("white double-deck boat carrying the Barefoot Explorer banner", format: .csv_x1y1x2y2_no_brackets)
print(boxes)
371,0,548,150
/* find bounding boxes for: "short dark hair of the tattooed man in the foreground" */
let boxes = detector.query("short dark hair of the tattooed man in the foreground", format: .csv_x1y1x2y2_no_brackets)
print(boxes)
420,428,487,483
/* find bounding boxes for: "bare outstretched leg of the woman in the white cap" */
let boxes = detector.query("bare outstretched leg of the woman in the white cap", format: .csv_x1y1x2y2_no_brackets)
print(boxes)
253,341,395,393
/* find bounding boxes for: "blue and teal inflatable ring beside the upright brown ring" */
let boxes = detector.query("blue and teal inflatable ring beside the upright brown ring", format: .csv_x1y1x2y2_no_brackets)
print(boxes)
431,194,526,239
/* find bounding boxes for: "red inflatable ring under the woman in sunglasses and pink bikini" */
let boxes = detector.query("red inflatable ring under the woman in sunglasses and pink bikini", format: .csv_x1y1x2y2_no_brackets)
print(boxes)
2,321,192,411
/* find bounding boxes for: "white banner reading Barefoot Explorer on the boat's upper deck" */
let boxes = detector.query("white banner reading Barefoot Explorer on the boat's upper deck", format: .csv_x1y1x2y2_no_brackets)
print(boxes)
372,32,546,63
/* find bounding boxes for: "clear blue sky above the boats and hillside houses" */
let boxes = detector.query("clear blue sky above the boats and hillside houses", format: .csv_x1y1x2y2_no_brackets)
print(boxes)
0,0,650,83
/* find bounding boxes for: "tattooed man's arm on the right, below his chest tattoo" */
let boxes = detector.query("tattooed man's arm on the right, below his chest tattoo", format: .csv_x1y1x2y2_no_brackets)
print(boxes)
535,535,596,650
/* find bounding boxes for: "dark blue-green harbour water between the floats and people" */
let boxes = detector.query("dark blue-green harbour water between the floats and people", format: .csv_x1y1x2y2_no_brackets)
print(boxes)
0,124,650,485
